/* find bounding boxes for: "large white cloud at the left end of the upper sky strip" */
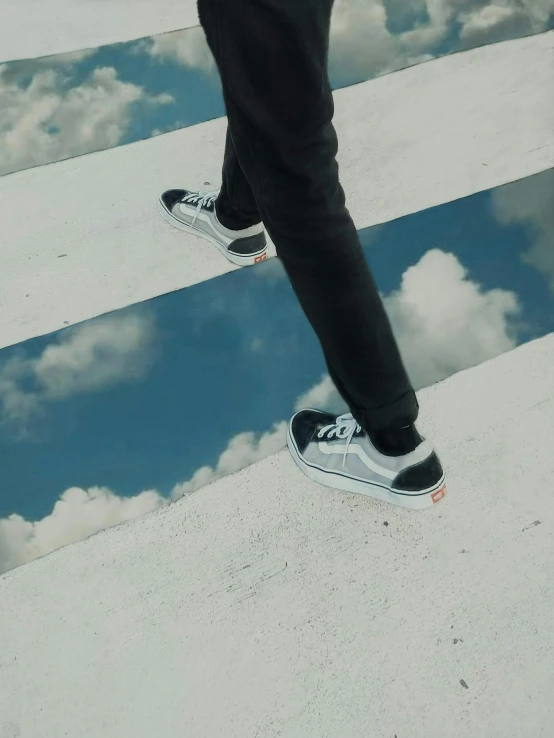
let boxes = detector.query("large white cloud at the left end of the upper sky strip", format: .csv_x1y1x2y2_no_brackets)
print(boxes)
0,64,173,174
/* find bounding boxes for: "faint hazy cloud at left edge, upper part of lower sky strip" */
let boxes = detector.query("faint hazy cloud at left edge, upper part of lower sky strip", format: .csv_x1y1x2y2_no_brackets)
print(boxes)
0,313,156,432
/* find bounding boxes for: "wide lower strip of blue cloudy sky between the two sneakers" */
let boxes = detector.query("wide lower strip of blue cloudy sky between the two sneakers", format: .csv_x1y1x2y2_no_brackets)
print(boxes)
0,170,554,571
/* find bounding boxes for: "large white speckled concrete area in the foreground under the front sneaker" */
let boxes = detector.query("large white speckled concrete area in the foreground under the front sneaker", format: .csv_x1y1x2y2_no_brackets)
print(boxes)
0,334,554,738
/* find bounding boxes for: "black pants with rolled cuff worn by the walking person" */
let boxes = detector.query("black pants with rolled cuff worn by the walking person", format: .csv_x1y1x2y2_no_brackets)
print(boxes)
198,0,418,431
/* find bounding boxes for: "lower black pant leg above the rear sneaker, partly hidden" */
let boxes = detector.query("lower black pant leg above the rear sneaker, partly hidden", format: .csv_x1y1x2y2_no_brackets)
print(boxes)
216,127,262,230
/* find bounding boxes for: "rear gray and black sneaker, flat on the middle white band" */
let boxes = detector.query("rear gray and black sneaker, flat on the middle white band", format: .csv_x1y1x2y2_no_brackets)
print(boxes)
159,190,267,266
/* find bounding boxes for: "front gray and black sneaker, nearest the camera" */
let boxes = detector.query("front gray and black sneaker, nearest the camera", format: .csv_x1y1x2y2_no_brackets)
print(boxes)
287,410,446,510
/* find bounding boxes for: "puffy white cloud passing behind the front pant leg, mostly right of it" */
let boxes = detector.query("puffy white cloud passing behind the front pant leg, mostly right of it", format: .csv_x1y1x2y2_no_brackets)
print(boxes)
296,249,519,413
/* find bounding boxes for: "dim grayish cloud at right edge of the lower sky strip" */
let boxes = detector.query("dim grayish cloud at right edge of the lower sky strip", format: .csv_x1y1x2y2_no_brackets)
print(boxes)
492,169,554,292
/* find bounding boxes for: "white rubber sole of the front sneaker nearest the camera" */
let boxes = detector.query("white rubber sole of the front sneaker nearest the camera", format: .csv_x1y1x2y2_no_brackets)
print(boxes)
287,426,446,510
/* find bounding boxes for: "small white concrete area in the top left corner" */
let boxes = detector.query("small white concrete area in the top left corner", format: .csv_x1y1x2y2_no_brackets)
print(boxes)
0,0,199,63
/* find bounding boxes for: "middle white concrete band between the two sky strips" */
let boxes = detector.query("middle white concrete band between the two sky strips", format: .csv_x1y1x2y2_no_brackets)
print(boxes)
0,32,554,347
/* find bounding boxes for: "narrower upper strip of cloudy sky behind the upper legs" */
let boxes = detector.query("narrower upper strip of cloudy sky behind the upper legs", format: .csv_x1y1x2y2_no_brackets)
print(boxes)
0,0,554,174
